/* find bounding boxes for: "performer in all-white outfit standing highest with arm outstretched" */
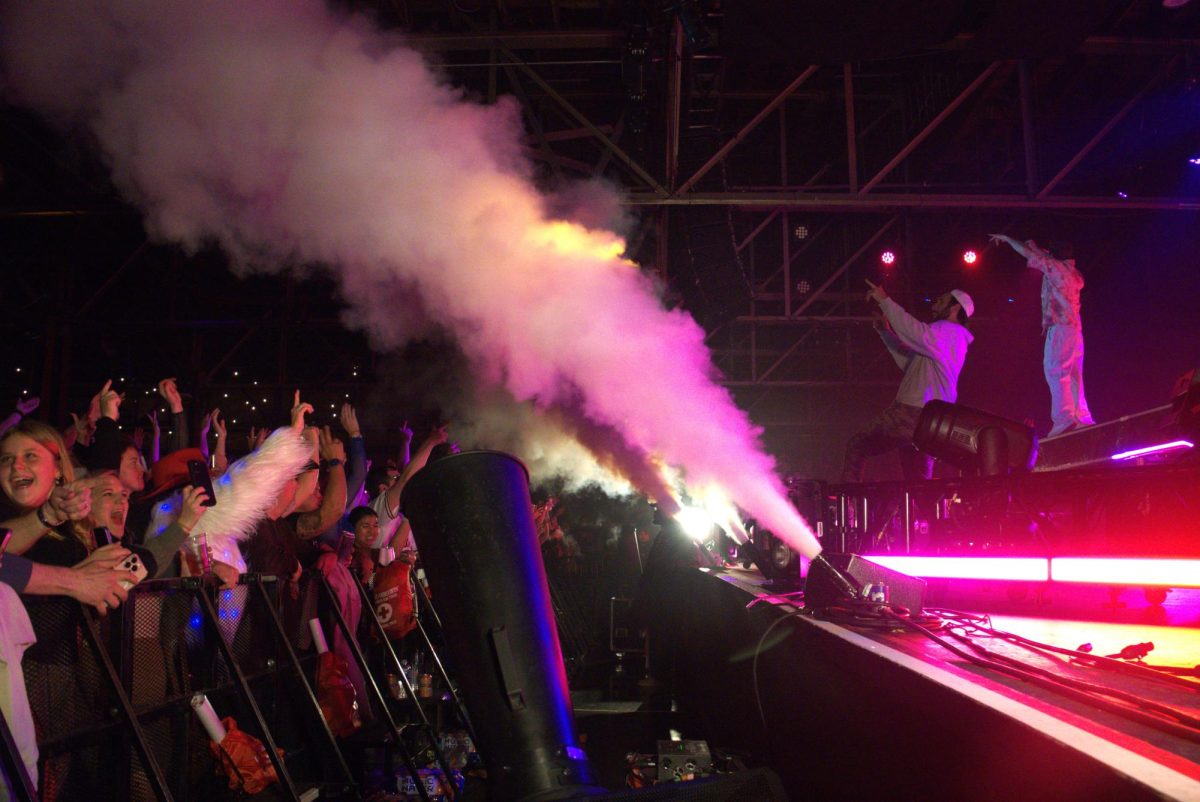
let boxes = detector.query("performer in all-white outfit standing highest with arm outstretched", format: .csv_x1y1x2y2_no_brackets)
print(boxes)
991,234,1096,437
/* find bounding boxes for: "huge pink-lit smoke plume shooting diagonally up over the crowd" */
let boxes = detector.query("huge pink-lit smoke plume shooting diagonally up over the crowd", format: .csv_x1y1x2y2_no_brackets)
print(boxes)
0,0,820,556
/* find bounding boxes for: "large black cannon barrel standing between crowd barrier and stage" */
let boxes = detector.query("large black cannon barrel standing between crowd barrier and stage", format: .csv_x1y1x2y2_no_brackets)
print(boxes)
401,451,601,801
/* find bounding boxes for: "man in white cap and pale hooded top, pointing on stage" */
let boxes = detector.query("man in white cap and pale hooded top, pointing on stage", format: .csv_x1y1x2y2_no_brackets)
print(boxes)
841,281,974,481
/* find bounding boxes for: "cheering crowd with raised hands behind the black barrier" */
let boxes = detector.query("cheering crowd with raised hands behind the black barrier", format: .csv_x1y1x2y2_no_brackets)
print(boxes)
0,378,452,782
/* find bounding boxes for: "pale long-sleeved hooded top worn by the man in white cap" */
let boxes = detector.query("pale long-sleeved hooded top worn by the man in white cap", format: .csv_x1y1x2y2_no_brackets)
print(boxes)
880,298,974,407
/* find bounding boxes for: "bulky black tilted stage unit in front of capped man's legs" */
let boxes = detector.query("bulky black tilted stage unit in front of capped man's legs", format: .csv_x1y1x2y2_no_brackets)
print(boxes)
912,401,1038,477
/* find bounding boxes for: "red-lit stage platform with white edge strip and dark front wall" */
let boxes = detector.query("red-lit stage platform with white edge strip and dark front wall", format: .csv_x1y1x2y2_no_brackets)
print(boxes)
682,569,1200,800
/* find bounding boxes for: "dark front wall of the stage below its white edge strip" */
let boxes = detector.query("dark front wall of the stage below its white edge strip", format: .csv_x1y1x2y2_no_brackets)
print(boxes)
676,571,1180,802
